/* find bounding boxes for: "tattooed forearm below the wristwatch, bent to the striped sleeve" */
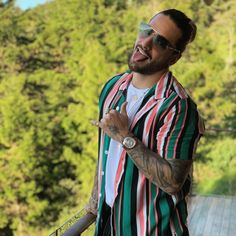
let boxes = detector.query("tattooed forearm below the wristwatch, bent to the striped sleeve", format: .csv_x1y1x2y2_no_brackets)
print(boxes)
127,138,192,194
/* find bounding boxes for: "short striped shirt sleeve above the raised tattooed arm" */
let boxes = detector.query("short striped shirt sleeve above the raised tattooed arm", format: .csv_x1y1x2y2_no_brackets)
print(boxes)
156,98,204,160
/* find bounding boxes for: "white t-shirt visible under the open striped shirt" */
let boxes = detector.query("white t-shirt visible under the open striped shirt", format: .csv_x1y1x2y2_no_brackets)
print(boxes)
105,83,149,207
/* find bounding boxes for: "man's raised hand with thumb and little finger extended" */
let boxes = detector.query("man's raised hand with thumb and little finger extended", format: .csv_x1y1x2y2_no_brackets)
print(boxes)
92,102,129,143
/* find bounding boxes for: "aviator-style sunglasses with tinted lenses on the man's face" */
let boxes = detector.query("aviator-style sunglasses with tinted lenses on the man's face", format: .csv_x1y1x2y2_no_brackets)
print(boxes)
139,22,180,53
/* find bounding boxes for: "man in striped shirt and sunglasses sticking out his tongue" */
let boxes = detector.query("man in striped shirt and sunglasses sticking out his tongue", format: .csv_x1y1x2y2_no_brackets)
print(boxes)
86,9,202,236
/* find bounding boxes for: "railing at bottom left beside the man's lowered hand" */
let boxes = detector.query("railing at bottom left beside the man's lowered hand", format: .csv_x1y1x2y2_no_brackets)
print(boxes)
49,210,96,236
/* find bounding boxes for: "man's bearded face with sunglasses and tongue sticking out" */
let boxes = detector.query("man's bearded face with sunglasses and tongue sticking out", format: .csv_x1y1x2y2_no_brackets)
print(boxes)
128,14,181,75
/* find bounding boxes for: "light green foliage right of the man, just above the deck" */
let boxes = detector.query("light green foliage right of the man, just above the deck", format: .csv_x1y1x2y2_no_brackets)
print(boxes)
194,137,236,195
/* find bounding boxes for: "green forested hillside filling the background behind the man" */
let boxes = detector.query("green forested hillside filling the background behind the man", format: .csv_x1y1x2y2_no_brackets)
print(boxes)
0,0,236,236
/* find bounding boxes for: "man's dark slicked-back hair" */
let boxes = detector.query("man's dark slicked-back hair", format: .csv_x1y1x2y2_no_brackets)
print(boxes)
153,9,197,52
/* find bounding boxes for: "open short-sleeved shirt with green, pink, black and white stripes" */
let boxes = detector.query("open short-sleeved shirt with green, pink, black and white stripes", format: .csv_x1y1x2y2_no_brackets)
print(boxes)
95,72,202,236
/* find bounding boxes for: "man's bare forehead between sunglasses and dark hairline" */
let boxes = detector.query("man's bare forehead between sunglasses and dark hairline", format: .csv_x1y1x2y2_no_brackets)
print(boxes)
149,14,182,45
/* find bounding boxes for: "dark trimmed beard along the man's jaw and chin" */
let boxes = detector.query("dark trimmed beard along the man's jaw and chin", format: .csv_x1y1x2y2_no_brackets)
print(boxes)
128,47,169,75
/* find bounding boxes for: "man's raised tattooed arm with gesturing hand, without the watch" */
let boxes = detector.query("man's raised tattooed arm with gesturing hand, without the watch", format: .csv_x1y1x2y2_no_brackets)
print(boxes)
93,102,196,194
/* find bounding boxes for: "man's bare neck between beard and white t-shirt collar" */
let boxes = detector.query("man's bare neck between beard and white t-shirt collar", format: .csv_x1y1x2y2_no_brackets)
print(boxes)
132,69,168,89
